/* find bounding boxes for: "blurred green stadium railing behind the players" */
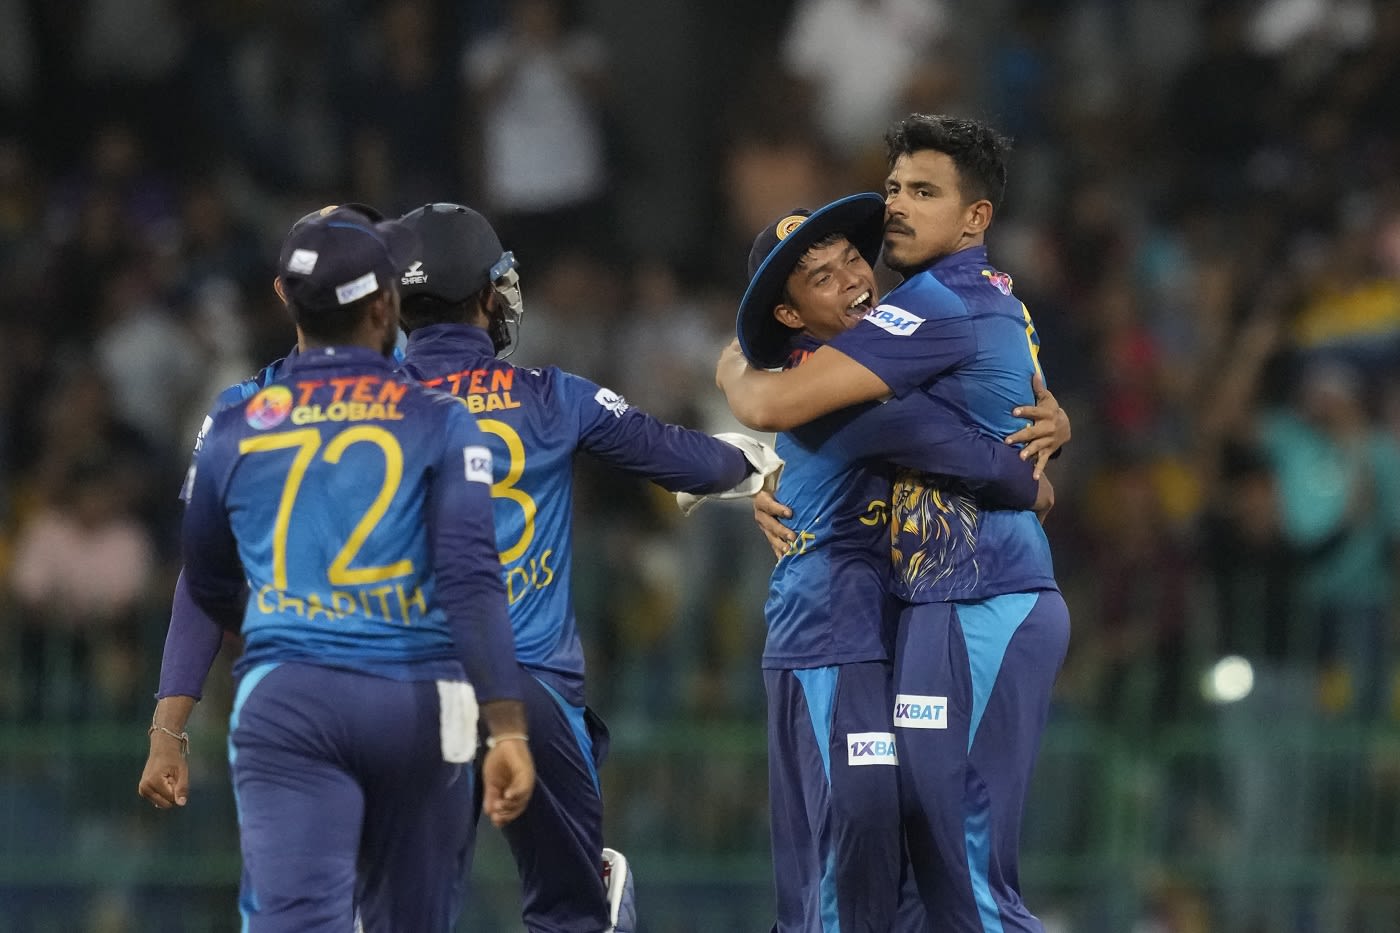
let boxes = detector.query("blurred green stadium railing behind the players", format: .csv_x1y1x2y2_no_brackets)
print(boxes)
0,716,1400,933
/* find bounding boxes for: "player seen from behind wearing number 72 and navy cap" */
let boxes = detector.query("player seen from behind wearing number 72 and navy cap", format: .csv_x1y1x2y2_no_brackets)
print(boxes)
182,210,533,933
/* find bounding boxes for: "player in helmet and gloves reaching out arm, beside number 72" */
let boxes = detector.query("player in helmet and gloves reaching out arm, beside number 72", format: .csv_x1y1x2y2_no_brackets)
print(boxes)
400,203,781,933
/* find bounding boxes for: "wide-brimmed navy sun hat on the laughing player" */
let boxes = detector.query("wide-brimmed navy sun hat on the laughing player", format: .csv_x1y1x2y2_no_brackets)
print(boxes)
736,192,885,370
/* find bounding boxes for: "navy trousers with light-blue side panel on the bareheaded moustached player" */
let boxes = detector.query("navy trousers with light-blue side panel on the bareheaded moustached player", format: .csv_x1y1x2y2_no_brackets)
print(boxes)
895,590,1070,933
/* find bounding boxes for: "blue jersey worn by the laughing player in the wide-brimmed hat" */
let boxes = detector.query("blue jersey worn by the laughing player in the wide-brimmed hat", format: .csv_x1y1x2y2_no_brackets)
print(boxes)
763,339,1039,670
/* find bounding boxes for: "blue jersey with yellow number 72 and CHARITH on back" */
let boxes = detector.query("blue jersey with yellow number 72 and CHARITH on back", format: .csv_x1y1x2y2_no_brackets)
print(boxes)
183,347,519,700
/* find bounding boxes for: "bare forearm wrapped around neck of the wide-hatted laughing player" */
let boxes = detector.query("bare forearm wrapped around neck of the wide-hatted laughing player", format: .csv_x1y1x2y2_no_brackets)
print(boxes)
714,340,889,431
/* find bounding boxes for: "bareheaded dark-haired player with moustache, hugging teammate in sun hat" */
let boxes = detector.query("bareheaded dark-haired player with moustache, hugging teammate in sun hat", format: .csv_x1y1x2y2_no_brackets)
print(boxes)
715,113,1070,933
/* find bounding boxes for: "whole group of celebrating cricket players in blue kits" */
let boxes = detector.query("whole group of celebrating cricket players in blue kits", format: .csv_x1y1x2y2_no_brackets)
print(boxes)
139,113,1070,933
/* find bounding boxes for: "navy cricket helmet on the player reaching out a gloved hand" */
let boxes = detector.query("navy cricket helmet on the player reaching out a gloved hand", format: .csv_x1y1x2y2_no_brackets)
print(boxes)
399,202,505,304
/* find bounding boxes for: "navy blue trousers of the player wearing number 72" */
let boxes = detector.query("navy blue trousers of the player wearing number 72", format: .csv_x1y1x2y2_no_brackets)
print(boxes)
228,663,475,933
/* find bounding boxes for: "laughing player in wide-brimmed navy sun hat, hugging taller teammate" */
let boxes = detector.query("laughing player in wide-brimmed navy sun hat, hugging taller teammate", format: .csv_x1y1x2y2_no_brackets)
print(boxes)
738,193,1049,933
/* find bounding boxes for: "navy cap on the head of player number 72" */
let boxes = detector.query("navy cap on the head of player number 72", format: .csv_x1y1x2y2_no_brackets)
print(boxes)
277,205,417,312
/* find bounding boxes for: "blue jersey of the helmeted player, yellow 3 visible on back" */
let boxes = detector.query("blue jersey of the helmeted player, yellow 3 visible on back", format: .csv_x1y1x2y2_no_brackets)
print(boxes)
403,324,750,677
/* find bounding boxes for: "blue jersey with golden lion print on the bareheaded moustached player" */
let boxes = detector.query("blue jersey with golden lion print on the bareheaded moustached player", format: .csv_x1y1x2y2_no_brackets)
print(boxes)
832,247,1058,602
